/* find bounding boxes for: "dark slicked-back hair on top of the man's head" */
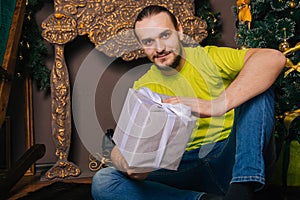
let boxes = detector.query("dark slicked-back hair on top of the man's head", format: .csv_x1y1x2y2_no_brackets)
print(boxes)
133,5,178,29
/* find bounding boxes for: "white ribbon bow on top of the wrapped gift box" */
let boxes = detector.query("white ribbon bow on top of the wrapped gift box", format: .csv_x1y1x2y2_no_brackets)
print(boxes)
138,87,192,125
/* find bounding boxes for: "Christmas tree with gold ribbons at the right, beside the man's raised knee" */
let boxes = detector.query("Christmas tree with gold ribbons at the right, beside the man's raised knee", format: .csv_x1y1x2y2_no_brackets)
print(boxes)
234,0,300,184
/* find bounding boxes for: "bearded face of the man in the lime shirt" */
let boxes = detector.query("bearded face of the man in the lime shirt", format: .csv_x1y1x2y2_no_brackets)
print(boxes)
135,12,183,71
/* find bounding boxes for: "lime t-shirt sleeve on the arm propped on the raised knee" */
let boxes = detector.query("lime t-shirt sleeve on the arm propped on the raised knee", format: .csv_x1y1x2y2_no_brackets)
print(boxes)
204,46,249,79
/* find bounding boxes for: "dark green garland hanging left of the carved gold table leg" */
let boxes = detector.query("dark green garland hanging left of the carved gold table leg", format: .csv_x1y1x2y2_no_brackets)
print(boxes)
17,0,50,91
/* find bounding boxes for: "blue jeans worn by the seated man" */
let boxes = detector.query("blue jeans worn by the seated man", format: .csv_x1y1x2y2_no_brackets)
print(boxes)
92,89,276,200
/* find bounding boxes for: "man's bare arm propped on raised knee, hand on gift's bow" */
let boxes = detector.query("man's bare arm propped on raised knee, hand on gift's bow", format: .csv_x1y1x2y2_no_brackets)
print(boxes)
163,48,286,117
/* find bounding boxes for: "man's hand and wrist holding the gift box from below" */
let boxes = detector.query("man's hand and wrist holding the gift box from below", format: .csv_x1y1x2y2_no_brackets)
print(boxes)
111,146,151,181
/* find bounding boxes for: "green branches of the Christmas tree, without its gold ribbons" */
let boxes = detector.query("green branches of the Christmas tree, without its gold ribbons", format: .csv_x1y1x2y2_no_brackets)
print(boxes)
234,0,300,142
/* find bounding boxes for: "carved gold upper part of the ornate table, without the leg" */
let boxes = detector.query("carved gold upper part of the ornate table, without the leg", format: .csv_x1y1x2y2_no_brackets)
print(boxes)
42,0,207,61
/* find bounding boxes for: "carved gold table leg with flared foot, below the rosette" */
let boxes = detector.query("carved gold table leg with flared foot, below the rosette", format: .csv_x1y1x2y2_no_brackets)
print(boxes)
46,44,80,179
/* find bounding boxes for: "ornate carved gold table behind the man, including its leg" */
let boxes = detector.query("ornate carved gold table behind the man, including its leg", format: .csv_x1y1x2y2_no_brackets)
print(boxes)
42,0,207,179
